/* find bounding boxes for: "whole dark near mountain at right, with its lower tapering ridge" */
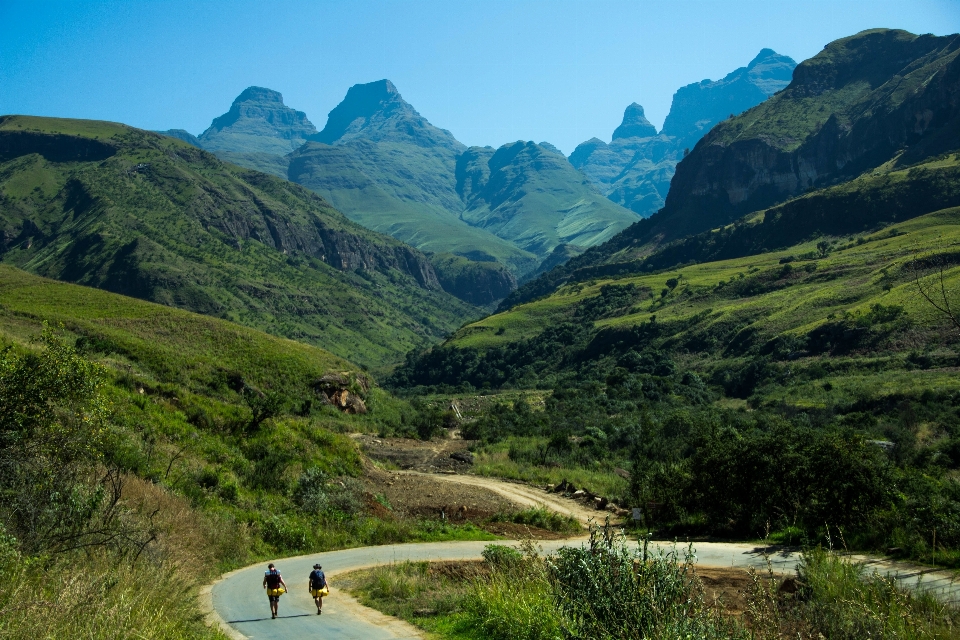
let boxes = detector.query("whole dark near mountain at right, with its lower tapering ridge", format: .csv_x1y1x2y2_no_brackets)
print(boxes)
501,29,960,309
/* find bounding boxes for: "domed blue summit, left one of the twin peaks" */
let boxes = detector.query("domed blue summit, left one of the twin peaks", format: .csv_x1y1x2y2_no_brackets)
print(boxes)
199,87,317,155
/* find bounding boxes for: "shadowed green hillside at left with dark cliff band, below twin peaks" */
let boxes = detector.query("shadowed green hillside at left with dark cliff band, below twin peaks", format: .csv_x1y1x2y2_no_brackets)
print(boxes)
0,116,477,367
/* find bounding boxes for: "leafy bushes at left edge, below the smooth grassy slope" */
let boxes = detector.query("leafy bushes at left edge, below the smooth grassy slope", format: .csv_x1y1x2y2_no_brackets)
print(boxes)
0,329,143,553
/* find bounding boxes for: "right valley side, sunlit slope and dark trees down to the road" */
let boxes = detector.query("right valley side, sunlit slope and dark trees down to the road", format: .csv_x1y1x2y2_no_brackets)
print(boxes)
391,209,960,564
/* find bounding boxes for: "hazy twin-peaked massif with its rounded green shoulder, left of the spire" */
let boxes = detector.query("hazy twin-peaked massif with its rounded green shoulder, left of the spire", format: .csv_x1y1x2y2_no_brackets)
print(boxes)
183,80,636,296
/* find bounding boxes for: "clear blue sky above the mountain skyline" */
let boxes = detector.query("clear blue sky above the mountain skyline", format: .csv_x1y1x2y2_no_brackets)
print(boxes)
0,0,960,153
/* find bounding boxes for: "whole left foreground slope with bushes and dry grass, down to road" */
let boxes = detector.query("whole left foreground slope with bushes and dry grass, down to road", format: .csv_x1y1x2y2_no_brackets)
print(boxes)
0,266,489,638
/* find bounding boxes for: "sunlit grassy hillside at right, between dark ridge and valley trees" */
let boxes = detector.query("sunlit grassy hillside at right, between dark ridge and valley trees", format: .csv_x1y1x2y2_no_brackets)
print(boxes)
398,208,960,392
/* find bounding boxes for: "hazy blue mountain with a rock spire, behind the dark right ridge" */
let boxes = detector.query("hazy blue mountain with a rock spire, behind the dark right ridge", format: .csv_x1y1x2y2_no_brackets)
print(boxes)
570,49,796,217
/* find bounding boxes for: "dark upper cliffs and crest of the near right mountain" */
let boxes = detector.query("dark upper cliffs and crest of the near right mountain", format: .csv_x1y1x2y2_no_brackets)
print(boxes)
660,29,960,239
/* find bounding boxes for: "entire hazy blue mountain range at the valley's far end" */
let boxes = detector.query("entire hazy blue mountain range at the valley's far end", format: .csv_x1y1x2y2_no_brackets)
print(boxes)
163,49,795,304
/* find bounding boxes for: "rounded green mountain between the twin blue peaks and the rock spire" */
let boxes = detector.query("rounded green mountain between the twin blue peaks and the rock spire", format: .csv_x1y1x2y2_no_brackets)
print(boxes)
457,142,636,259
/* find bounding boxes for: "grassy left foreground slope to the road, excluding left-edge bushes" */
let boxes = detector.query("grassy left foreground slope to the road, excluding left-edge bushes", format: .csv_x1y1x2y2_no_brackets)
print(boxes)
0,265,498,640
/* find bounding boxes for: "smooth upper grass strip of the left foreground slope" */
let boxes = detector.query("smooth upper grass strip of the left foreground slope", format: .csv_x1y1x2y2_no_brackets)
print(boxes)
0,265,358,394
